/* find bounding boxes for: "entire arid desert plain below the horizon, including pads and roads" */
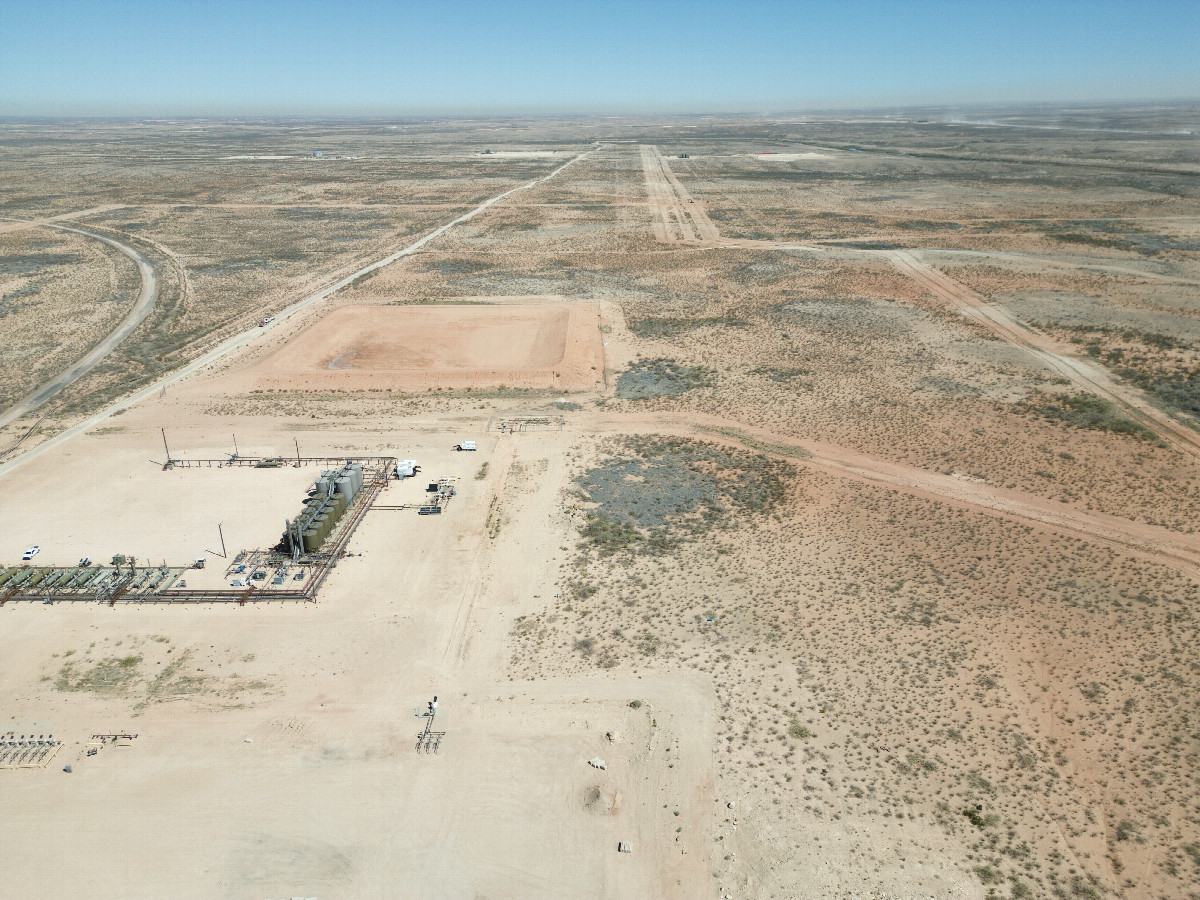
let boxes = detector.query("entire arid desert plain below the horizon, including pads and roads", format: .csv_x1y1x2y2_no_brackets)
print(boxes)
0,111,1200,900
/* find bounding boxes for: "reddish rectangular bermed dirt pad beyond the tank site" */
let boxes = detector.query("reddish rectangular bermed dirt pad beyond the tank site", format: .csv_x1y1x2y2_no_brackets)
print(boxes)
254,301,604,390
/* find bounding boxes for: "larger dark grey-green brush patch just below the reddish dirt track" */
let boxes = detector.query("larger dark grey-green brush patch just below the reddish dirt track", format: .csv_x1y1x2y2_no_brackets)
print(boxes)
575,437,792,554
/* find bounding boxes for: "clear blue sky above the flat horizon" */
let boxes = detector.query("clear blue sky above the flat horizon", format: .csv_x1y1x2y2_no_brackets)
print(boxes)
0,0,1200,116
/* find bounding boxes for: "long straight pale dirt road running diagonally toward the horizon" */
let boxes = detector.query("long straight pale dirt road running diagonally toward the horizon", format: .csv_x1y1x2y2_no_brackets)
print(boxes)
0,150,593,478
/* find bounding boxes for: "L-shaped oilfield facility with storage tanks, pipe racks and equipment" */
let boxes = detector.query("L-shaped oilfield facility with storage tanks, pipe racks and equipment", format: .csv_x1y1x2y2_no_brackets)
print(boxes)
0,454,457,606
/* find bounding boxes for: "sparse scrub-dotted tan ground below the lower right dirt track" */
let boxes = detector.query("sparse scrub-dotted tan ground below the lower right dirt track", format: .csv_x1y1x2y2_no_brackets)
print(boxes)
511,458,1200,896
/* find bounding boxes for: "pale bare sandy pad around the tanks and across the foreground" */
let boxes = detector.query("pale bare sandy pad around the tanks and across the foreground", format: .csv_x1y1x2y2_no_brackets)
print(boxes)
4,404,715,898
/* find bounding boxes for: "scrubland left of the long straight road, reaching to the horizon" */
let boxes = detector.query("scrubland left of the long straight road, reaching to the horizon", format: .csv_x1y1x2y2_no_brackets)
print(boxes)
0,122,577,446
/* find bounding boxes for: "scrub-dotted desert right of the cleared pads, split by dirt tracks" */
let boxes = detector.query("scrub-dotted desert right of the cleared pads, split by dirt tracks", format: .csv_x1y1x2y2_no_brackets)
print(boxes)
386,121,1200,896
